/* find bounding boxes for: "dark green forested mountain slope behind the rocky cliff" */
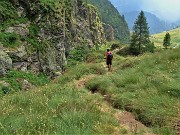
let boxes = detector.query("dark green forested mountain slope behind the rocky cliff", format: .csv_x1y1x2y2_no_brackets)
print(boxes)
86,0,130,41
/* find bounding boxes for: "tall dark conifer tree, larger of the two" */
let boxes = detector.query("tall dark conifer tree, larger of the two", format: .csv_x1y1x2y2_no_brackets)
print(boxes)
130,11,154,55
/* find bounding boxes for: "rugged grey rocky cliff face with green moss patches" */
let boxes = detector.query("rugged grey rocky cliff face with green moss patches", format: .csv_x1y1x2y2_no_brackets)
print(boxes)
0,0,105,77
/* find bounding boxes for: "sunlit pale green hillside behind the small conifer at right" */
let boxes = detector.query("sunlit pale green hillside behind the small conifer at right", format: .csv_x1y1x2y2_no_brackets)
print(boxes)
151,28,180,48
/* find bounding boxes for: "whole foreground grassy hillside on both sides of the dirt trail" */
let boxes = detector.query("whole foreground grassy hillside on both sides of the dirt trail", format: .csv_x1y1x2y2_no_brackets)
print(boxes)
0,49,180,135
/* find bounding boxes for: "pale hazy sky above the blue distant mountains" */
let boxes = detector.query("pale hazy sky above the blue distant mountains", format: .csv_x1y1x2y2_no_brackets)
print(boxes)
110,0,180,22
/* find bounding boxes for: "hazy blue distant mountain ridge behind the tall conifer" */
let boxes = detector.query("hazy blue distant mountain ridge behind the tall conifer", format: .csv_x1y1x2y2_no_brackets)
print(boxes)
109,0,180,34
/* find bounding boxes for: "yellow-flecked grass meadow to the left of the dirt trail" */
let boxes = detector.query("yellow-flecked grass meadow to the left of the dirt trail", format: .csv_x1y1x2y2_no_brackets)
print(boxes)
0,84,121,135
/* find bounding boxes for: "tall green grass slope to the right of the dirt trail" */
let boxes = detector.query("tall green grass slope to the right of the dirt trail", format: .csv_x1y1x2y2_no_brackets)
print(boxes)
86,49,180,134
